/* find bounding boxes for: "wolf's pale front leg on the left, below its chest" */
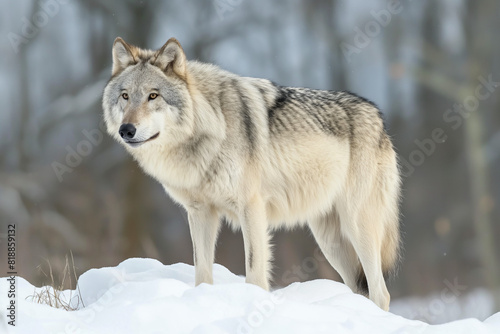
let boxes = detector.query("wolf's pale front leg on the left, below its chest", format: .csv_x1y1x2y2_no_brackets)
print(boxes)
188,207,220,285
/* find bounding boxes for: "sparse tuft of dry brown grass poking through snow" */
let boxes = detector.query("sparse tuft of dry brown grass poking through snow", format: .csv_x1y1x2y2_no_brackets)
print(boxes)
27,252,85,311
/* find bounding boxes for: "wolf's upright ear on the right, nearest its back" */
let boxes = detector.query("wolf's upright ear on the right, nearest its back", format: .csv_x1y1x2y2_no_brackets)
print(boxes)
153,38,186,80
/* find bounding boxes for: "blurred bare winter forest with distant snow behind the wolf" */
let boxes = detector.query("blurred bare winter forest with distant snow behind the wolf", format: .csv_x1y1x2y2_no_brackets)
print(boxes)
0,0,500,322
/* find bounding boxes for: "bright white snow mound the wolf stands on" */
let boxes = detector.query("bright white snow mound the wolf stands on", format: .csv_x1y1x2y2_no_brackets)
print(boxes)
0,258,500,334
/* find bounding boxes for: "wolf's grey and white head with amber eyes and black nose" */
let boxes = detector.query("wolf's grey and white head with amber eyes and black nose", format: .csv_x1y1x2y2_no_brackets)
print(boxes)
103,37,193,151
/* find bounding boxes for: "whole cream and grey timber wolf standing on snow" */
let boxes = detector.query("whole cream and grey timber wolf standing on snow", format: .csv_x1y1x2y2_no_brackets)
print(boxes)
103,38,400,310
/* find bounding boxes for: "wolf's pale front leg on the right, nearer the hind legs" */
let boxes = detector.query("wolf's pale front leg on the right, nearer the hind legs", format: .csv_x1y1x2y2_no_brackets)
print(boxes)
240,196,271,290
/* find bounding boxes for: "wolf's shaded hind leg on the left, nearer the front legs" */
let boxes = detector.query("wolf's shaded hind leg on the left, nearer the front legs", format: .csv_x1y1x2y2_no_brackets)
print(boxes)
309,209,360,292
